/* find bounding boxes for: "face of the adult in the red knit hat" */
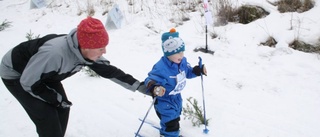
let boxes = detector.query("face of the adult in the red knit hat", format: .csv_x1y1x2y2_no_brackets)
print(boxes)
81,47,106,61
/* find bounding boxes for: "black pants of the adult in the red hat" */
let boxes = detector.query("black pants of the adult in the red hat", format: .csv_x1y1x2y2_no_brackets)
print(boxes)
2,79,70,137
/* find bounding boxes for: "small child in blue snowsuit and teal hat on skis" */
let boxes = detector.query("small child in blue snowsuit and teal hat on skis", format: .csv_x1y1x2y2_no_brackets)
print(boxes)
145,28,207,137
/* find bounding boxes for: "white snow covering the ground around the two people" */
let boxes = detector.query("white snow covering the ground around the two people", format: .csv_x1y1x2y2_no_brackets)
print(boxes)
0,0,320,137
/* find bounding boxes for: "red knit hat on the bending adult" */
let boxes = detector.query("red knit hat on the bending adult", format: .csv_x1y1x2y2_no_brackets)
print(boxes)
77,17,109,49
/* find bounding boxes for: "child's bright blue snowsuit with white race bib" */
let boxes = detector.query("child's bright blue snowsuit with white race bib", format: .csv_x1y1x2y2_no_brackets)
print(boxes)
145,56,197,120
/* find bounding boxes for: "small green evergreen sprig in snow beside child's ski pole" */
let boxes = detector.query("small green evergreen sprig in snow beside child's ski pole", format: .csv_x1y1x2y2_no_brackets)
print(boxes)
183,97,209,126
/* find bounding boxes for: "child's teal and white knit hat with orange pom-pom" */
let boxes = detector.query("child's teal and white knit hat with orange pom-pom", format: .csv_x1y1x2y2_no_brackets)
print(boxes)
161,28,185,56
